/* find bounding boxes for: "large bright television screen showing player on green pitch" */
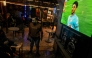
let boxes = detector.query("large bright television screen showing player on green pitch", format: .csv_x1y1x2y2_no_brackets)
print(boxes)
60,0,92,37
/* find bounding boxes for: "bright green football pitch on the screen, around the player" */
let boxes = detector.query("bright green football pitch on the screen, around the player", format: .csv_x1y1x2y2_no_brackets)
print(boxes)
61,0,92,37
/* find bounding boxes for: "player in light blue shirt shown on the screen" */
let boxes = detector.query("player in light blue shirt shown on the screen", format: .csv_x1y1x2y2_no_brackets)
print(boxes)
67,1,79,31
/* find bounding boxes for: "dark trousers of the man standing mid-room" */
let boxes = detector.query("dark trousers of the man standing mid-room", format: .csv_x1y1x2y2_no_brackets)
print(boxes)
30,37,40,53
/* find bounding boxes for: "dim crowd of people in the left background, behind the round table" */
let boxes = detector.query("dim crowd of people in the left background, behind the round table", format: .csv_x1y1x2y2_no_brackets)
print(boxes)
0,10,31,27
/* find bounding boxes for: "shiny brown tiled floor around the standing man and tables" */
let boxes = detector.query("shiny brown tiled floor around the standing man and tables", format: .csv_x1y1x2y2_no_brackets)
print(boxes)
4,27,56,58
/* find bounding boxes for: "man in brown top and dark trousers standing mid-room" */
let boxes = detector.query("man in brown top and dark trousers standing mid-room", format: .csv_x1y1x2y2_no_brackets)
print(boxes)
29,18,43,56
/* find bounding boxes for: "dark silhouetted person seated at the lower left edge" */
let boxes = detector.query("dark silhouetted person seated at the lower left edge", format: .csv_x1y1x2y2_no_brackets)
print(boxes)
0,26,16,57
